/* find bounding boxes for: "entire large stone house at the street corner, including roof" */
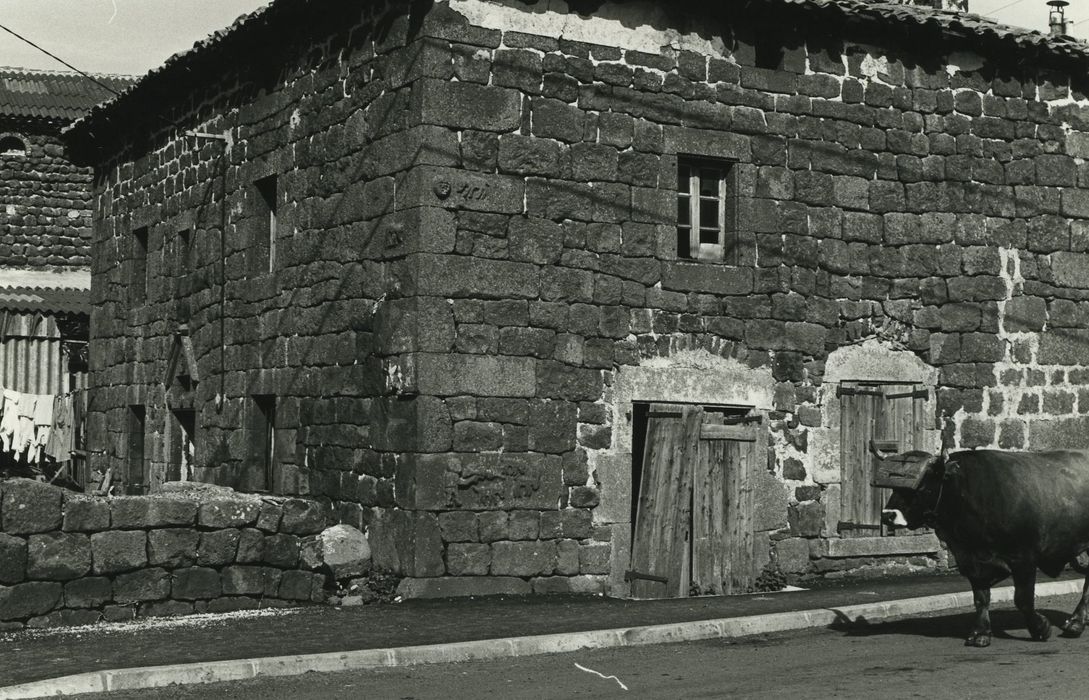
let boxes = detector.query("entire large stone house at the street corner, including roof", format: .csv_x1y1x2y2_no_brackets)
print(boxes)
61,0,1089,597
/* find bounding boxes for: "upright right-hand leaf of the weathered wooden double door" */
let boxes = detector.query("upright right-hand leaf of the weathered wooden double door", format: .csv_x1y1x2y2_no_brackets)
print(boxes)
692,413,767,594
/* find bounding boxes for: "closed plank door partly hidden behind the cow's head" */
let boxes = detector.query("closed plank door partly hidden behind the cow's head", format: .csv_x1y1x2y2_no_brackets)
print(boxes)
839,382,928,537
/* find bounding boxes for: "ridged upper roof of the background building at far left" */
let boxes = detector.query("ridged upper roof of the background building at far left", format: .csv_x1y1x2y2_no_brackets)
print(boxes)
0,66,135,121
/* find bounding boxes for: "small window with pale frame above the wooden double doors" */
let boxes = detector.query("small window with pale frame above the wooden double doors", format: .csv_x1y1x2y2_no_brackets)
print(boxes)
677,157,738,265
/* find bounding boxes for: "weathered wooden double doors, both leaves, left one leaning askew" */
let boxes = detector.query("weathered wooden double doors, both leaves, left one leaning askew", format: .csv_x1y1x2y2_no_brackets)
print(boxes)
627,404,767,598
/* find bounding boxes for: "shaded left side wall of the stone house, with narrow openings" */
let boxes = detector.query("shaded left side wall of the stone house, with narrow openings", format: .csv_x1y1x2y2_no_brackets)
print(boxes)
88,3,415,528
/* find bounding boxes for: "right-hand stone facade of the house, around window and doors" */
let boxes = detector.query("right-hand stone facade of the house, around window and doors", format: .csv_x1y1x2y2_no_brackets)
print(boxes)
388,1,1089,592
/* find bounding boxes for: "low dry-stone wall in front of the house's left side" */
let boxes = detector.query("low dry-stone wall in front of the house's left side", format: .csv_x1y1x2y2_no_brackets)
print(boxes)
0,479,327,630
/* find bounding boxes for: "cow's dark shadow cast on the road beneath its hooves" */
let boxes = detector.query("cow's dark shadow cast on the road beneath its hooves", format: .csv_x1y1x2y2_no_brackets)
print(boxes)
830,609,1069,641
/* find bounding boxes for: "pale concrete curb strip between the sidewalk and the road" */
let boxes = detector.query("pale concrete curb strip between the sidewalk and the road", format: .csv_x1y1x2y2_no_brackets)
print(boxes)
0,580,1082,700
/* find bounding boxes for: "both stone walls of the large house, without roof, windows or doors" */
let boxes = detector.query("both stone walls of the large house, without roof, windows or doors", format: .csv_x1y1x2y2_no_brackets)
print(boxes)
84,0,1089,594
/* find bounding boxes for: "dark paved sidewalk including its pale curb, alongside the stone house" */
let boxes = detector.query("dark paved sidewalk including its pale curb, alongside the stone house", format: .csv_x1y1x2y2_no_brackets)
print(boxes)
0,576,1080,698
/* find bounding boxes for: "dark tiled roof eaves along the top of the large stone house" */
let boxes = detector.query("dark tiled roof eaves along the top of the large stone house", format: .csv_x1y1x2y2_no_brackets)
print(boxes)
66,0,1089,151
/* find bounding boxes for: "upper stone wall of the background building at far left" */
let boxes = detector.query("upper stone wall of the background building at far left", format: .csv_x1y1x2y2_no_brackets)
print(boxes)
0,119,91,270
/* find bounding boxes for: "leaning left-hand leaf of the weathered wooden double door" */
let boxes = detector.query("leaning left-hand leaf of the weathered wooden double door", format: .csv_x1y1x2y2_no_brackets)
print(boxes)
627,404,703,598
